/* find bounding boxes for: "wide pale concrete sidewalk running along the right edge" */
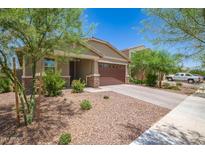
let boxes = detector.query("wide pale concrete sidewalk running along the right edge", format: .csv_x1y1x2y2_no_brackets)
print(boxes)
131,85,205,145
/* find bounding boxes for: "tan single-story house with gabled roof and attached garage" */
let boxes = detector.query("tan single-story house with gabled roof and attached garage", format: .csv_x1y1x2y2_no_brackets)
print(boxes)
19,38,129,89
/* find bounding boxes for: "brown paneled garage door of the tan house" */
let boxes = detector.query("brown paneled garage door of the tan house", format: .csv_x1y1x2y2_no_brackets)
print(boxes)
98,63,125,86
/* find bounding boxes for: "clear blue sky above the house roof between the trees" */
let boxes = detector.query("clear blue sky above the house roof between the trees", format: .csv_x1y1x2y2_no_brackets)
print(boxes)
84,8,197,67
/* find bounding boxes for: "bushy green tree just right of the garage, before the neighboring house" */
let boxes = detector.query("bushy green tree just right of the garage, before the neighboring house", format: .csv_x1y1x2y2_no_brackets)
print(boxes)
130,50,180,88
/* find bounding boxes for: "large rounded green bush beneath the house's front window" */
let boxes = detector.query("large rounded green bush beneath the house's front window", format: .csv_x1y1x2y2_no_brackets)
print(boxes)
43,71,65,96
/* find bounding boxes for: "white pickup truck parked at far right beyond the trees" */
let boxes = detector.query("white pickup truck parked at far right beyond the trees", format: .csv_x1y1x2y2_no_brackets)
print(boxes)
166,73,203,83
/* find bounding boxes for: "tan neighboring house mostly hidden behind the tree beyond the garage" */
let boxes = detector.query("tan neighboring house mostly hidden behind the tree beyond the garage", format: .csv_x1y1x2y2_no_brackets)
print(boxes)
121,45,150,80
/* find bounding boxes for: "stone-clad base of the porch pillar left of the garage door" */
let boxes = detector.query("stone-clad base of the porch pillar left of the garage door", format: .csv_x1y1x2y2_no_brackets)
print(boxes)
86,74,100,88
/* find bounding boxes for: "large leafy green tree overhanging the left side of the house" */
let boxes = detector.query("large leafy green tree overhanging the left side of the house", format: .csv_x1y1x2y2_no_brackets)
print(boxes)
0,9,86,124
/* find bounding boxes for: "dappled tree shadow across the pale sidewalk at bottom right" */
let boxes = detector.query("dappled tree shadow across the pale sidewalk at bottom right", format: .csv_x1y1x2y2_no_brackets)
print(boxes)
134,124,205,145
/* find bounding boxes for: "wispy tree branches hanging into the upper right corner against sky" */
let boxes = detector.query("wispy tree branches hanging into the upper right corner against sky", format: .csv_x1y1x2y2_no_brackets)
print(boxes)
143,9,205,65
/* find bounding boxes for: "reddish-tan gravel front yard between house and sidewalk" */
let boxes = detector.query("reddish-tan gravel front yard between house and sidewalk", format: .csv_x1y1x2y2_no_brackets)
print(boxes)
0,90,169,144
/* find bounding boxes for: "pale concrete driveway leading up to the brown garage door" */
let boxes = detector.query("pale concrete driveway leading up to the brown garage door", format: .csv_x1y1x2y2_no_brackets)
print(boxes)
86,84,187,109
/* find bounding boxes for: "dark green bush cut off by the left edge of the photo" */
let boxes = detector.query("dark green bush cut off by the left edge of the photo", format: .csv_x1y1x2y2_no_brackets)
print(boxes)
0,76,11,93
